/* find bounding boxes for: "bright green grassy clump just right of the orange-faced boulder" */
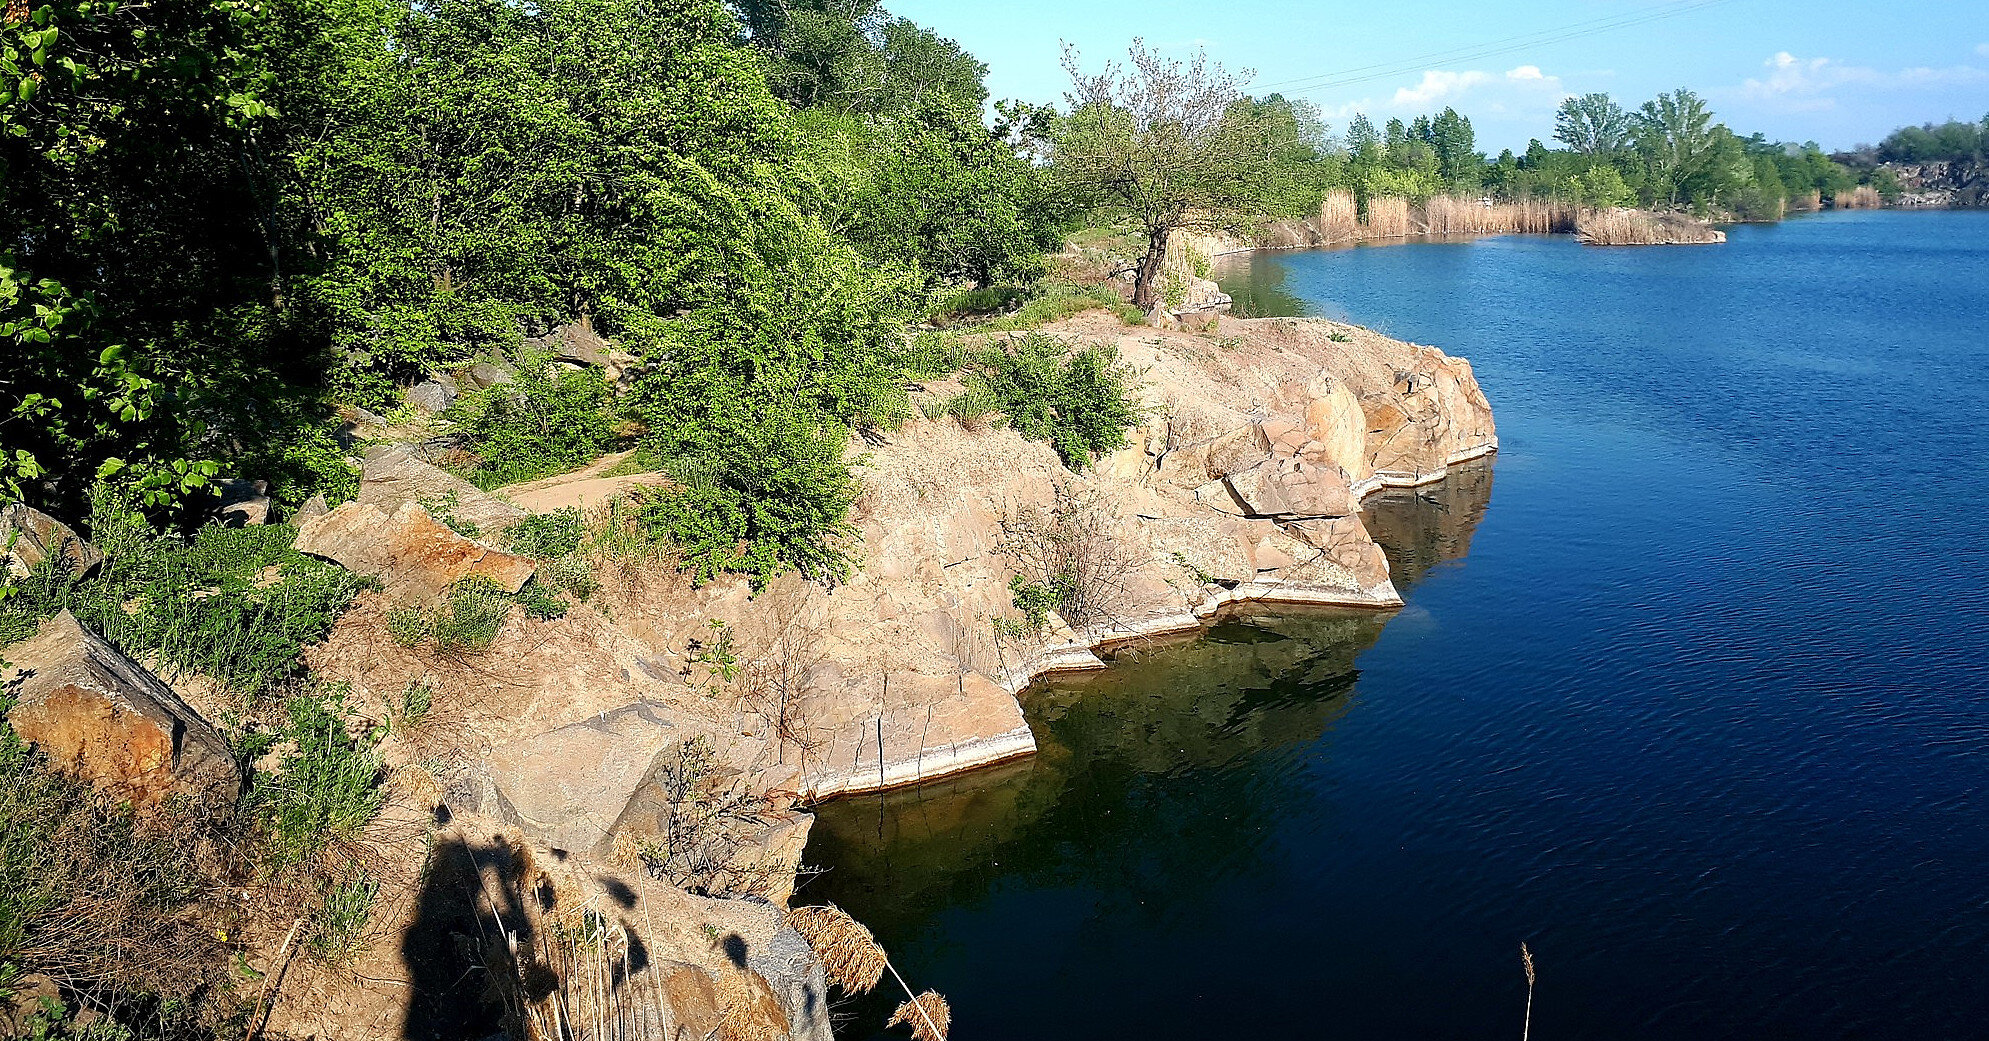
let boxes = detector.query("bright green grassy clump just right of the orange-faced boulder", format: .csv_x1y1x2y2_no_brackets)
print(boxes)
245,689,386,870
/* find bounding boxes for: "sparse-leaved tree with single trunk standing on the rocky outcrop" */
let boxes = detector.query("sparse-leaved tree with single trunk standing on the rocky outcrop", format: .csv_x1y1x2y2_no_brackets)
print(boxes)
1052,38,1263,309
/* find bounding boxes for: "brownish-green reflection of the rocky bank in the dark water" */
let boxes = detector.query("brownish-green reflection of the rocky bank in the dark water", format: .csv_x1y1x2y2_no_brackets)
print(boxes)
798,462,1492,1019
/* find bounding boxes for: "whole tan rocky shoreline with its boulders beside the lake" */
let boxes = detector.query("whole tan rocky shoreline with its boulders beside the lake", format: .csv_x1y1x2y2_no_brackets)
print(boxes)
10,300,1498,1039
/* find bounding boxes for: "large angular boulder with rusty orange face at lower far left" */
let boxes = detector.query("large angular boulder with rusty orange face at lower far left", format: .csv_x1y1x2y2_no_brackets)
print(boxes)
8,611,241,806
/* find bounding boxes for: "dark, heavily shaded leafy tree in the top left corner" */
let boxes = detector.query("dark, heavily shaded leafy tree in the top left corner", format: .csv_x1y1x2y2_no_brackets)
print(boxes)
0,0,294,516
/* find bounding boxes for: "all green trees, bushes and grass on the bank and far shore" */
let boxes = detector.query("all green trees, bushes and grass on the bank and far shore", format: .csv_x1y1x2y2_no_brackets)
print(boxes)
0,0,1989,1041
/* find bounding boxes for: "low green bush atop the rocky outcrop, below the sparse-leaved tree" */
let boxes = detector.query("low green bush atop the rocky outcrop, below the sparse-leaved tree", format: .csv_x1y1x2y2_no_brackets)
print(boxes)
969,334,1140,470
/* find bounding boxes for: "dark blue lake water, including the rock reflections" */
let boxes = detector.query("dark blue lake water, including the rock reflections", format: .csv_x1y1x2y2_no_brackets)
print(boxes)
804,213,1989,1041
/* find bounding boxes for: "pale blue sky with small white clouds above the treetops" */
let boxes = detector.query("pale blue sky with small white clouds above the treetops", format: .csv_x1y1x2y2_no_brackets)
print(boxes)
885,0,1989,153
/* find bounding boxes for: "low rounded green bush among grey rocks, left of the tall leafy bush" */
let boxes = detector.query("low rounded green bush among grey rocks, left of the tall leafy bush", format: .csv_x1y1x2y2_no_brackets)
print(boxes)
444,356,615,490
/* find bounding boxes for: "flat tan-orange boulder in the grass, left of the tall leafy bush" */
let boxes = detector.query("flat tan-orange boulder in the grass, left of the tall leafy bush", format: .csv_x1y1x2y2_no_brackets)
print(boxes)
296,502,537,603
